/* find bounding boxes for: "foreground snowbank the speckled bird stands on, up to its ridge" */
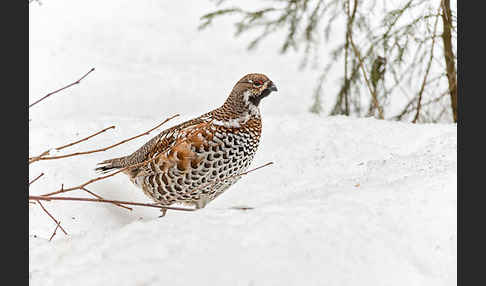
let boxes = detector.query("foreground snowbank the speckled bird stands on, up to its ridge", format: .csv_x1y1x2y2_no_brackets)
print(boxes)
29,114,457,286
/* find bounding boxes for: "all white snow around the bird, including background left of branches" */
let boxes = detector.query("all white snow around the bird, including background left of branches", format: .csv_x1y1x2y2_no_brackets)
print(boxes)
29,0,457,286
